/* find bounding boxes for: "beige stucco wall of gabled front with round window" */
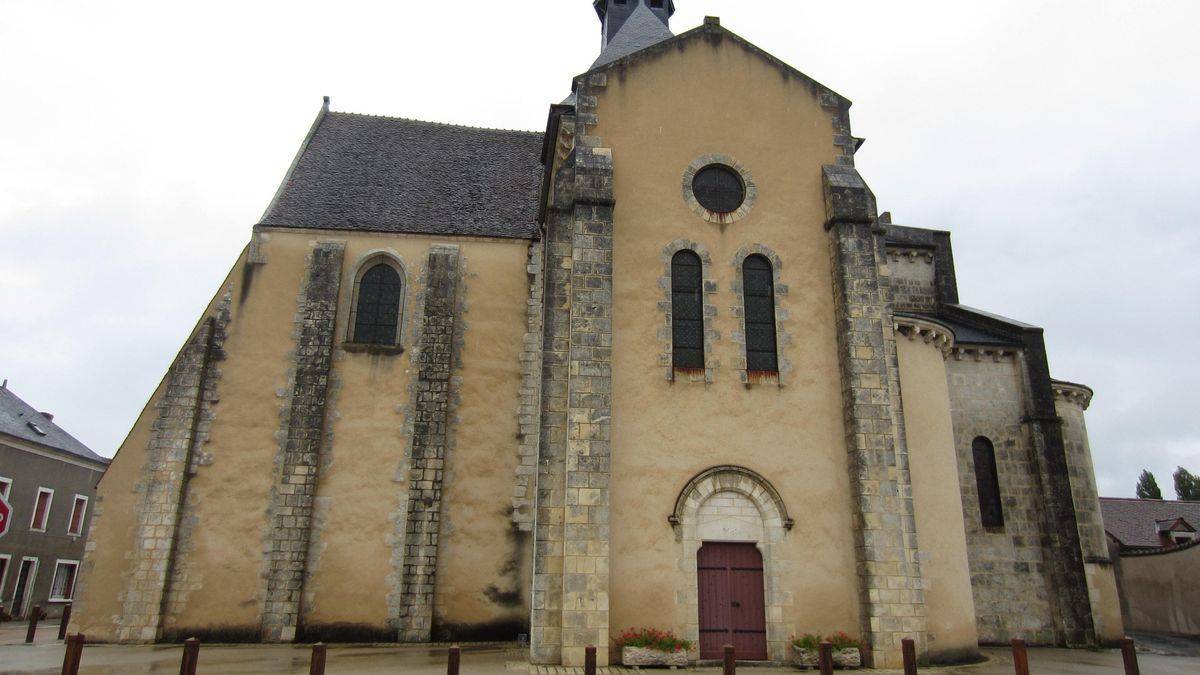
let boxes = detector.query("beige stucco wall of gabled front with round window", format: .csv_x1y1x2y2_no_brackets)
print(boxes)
594,32,858,659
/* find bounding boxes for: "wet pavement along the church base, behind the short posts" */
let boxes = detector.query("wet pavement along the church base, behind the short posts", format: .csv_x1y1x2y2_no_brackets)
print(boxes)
0,622,1200,675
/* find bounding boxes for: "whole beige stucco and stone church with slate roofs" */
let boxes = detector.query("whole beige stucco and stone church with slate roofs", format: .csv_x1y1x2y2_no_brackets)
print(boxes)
71,0,1122,667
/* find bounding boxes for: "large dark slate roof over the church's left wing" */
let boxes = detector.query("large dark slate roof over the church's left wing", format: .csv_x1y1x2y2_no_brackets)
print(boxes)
259,110,542,239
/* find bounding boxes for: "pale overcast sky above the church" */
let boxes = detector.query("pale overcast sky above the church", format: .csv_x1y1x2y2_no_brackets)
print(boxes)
0,0,1200,497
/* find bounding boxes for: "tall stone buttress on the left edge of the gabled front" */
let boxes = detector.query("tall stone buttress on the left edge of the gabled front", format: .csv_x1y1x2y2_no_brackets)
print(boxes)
530,73,614,667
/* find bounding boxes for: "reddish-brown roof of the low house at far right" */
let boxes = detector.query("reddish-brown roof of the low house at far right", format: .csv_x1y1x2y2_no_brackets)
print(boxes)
1100,497,1200,552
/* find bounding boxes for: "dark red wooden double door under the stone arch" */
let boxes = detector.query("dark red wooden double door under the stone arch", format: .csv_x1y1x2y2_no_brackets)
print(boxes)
697,543,767,661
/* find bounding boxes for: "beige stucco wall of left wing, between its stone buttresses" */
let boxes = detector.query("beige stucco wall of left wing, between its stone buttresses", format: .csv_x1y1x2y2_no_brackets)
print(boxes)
76,232,530,640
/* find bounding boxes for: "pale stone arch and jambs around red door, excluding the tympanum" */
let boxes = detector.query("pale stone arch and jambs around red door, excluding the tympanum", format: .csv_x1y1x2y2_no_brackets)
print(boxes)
668,466,796,662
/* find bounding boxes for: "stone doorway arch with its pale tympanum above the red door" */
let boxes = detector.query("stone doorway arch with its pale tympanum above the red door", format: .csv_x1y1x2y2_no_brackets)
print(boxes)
670,466,794,662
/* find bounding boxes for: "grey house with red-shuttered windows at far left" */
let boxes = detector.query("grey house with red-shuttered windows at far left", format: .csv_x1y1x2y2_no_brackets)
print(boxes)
0,380,108,619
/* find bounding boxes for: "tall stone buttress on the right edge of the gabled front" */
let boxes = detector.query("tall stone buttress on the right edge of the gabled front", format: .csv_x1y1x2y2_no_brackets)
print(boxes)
824,165,925,668
